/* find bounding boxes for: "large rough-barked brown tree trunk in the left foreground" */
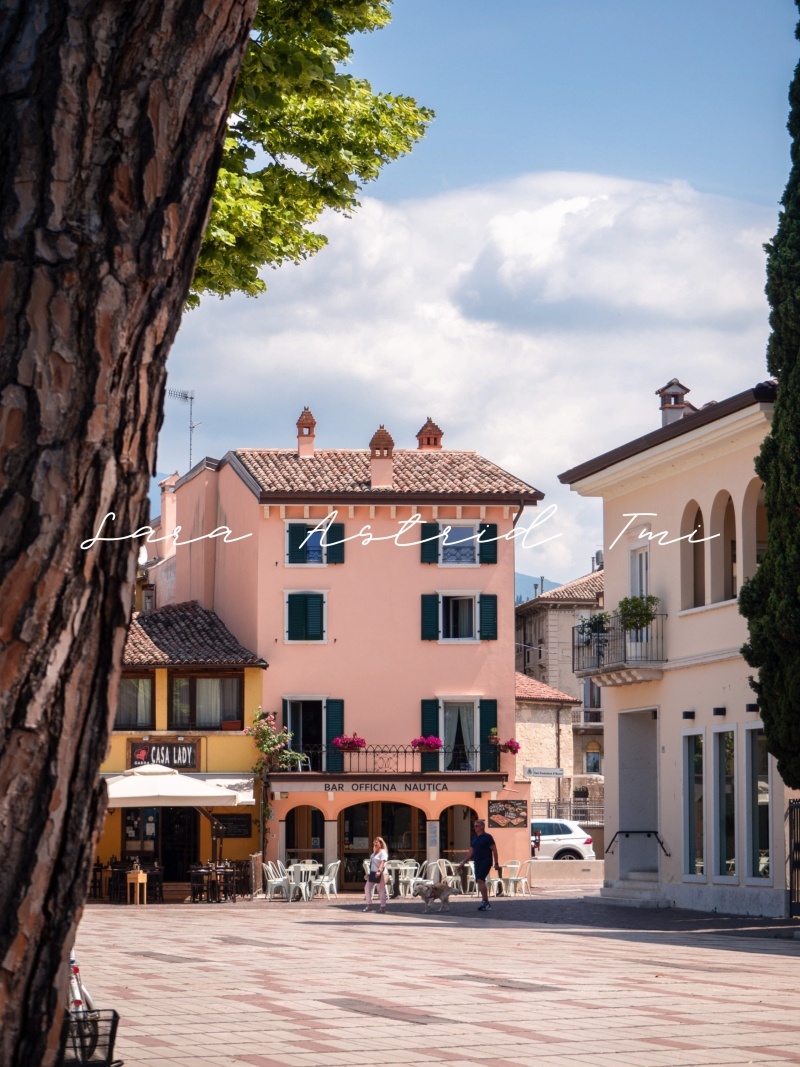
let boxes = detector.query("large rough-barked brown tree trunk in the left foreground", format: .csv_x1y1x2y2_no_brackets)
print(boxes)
0,0,256,1067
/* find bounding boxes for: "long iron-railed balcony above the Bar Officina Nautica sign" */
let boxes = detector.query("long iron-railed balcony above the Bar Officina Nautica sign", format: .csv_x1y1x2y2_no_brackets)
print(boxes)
273,744,500,778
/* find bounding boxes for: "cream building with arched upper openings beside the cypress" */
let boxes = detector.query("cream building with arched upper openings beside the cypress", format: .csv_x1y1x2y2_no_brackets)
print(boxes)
560,379,788,917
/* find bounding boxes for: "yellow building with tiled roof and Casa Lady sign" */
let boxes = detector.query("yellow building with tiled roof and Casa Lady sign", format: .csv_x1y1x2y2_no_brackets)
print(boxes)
98,602,267,882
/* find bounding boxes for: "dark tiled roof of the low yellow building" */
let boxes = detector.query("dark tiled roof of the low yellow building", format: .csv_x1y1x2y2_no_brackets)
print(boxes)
123,601,267,667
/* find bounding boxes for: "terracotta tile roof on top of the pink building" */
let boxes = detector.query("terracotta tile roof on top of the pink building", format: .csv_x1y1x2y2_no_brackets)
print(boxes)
229,448,542,504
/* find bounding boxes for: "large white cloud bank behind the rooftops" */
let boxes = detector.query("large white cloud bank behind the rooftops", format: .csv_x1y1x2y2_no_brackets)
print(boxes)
159,174,775,580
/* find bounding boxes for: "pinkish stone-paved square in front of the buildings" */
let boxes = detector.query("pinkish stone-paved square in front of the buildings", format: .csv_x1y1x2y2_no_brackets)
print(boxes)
77,887,800,1067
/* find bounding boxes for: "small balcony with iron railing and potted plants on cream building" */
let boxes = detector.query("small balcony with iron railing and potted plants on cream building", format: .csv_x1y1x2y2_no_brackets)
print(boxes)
572,615,667,685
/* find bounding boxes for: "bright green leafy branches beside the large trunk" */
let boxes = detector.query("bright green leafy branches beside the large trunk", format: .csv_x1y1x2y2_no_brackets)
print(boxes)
189,0,433,306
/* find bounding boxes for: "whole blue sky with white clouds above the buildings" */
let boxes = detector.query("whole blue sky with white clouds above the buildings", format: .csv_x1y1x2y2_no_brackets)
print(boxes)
158,0,800,580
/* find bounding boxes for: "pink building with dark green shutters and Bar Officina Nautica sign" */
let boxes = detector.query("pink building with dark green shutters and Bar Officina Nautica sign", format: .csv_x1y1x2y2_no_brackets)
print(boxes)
148,408,542,886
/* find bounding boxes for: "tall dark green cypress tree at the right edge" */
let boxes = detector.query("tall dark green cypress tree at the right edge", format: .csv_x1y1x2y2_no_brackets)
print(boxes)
739,0,800,789
